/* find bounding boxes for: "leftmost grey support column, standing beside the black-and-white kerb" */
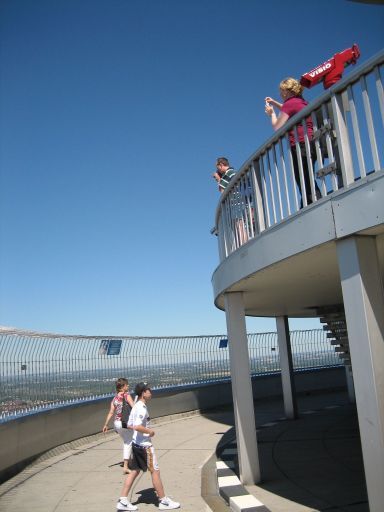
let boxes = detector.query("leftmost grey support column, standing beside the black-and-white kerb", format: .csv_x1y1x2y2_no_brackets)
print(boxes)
224,292,260,485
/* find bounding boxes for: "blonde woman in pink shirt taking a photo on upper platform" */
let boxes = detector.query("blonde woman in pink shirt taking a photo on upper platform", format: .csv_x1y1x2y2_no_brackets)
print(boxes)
265,78,321,206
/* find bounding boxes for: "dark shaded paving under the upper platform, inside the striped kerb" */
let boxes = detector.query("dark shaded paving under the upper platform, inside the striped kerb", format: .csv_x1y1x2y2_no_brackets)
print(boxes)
222,393,369,512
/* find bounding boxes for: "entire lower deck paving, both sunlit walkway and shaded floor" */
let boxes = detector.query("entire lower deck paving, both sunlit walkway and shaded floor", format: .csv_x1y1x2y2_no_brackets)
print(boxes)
0,393,369,512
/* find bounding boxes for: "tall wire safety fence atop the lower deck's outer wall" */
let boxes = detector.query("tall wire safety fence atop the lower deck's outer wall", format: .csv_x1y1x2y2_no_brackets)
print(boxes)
0,329,340,422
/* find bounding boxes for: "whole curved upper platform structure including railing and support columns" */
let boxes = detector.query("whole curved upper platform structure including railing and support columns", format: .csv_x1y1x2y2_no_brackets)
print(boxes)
212,51,384,512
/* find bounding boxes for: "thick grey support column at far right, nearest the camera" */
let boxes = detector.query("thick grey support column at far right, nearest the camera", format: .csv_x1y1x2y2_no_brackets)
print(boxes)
337,237,384,512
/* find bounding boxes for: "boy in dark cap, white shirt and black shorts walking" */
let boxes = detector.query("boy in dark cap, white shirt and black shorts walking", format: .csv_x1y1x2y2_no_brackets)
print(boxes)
116,382,180,510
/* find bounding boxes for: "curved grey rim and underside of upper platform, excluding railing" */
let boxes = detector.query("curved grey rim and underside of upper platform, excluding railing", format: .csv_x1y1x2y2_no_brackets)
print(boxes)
212,172,384,317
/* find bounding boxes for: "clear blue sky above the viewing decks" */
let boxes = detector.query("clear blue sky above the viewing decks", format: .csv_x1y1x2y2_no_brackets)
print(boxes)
0,0,384,336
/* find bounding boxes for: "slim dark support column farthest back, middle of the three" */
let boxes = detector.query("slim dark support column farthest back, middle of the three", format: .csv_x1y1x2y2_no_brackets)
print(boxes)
276,316,297,420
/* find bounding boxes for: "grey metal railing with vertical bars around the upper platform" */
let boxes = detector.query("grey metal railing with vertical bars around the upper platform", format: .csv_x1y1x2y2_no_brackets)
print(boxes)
213,51,384,261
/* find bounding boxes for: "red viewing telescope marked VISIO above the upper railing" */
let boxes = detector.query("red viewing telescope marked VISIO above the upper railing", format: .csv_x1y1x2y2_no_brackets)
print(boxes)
300,44,360,89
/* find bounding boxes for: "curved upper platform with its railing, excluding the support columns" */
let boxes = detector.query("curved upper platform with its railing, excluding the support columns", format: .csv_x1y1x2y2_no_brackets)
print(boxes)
212,52,384,317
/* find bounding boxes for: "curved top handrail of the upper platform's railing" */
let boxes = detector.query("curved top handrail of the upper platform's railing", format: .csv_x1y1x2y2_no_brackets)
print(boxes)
212,49,384,232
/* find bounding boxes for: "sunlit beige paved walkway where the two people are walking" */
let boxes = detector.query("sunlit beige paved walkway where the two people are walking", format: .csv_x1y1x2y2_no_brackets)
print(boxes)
0,413,231,512
